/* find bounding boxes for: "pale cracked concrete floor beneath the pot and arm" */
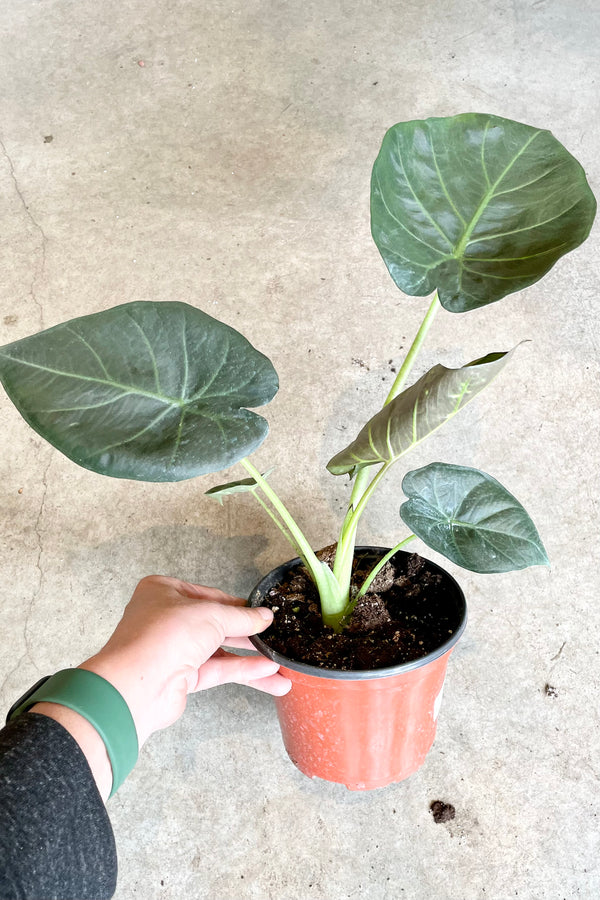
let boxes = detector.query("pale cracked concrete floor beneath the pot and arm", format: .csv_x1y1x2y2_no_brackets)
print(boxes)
0,0,600,900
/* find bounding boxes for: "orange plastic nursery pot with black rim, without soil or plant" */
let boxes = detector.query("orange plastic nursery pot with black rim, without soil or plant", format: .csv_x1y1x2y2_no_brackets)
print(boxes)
249,547,467,791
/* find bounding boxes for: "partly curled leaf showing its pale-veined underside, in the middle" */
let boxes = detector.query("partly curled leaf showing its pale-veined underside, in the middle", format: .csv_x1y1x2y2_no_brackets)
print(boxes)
327,350,514,475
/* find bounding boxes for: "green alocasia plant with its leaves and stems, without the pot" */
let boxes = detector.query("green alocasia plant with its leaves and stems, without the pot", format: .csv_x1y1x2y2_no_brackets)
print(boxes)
0,113,596,630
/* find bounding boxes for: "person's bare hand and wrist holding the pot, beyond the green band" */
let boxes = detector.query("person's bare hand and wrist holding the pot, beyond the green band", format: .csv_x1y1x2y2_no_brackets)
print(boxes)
79,575,291,747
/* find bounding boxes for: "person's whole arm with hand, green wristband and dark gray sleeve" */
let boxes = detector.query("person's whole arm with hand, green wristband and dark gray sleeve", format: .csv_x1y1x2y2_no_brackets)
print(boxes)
0,576,290,900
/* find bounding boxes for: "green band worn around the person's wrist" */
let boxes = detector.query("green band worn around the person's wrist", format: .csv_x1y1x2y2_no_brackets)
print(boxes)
10,669,139,797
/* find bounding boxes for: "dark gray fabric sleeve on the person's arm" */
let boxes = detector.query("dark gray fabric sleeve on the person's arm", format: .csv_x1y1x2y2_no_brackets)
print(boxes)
0,713,117,900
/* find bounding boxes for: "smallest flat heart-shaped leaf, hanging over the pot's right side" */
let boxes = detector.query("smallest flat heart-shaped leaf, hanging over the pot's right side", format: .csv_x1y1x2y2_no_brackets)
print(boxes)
400,463,548,573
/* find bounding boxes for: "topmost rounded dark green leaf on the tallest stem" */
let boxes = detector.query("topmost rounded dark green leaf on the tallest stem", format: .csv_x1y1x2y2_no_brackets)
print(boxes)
371,113,596,312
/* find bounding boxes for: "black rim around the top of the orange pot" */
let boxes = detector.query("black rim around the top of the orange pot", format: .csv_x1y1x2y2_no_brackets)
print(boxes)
248,546,467,681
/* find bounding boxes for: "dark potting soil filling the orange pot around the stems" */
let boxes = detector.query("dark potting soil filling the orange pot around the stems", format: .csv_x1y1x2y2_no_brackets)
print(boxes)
260,548,460,671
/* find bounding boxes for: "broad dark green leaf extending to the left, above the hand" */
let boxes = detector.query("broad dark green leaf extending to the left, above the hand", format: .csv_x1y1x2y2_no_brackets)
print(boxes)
0,302,278,481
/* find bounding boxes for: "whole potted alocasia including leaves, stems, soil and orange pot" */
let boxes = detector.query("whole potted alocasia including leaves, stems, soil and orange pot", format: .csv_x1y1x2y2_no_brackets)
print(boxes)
0,113,596,789
